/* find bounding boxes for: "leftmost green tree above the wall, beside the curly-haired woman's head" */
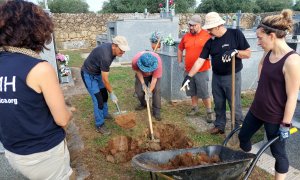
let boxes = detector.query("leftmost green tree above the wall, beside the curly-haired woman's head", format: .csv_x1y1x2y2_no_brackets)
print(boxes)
48,0,89,13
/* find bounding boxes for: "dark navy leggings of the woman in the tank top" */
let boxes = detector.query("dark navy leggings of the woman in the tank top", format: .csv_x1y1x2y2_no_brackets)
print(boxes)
239,111,289,173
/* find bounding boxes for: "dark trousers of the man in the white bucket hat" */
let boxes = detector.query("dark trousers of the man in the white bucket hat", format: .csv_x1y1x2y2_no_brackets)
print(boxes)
212,72,243,131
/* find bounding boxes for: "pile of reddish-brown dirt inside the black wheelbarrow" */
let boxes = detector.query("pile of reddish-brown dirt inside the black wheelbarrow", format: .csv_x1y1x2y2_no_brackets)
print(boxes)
158,152,221,170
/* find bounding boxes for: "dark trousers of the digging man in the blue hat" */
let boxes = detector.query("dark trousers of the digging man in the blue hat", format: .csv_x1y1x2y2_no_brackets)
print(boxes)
135,76,161,115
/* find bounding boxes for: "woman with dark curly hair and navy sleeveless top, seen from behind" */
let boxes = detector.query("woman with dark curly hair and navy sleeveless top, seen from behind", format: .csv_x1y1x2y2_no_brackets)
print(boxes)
0,0,72,179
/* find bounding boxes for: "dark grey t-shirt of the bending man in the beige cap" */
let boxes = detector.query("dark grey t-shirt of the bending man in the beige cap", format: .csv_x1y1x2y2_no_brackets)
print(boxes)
81,43,116,75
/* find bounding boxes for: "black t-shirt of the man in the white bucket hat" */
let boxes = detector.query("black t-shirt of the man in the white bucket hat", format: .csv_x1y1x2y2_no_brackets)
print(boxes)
200,29,250,75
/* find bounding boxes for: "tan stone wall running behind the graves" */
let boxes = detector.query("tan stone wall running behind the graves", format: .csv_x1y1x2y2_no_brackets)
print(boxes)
52,13,298,50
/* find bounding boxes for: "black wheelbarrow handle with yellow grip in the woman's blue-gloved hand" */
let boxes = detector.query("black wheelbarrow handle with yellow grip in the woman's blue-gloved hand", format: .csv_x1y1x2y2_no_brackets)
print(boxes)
244,127,298,180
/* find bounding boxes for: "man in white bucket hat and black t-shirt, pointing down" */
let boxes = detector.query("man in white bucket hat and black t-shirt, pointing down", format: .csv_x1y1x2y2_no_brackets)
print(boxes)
182,12,251,134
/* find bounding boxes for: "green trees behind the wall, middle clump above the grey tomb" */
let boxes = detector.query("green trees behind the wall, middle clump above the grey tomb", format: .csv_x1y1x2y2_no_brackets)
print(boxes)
100,0,196,13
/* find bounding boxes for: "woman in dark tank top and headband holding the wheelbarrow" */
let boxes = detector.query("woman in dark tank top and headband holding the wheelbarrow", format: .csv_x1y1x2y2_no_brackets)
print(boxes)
239,9,300,180
